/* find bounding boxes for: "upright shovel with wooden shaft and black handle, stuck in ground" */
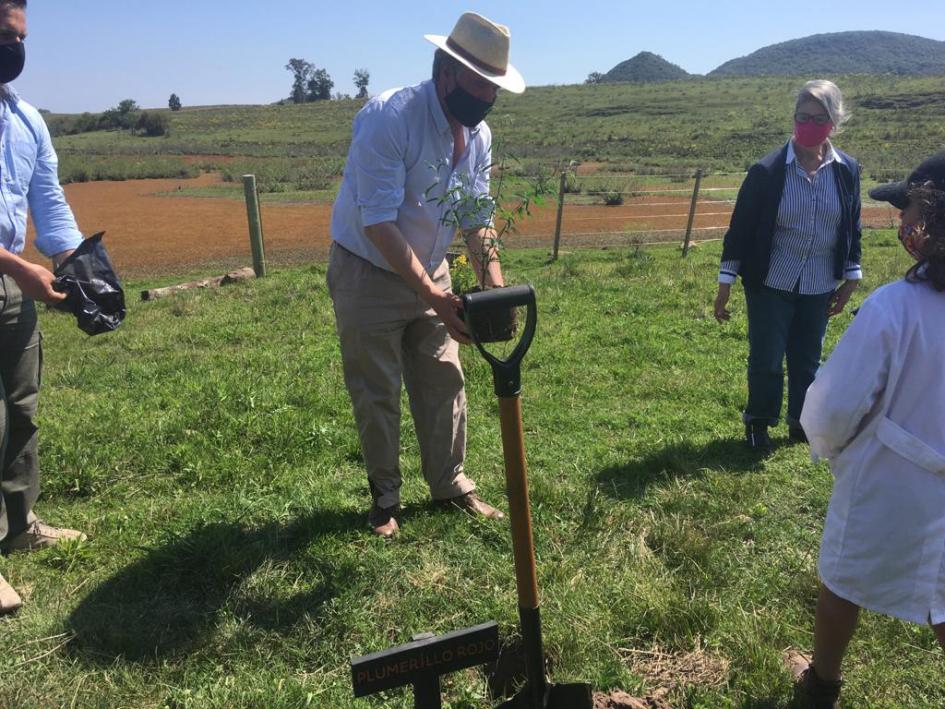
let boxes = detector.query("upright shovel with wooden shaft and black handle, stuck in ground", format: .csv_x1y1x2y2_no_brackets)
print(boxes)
463,286,593,709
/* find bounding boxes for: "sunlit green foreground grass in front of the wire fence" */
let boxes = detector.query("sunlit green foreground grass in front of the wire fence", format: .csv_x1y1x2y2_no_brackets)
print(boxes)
0,232,945,709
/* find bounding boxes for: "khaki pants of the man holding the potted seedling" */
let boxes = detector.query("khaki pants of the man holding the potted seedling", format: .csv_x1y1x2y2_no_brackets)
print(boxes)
328,244,475,507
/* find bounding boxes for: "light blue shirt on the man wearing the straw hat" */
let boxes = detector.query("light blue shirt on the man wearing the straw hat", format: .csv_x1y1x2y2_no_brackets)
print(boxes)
331,80,494,274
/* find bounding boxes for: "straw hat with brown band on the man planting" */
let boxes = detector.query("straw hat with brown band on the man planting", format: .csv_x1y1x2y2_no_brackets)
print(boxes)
423,12,525,94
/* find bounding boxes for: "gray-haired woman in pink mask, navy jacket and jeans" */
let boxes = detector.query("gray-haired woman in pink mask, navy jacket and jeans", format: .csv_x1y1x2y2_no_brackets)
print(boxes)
715,79,863,452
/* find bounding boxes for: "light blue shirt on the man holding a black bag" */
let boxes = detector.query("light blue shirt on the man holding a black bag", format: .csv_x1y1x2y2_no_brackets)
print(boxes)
0,86,82,257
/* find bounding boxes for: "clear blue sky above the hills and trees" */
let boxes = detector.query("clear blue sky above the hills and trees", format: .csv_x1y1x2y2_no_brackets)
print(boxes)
15,0,945,112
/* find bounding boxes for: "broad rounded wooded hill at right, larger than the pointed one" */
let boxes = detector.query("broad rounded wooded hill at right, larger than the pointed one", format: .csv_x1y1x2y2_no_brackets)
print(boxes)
709,32,945,77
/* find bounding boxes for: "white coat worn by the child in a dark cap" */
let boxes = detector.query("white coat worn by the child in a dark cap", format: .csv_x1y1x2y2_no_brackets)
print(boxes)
801,280,945,624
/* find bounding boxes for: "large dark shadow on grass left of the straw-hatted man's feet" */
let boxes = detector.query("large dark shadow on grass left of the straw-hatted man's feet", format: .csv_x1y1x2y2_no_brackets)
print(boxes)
67,511,364,665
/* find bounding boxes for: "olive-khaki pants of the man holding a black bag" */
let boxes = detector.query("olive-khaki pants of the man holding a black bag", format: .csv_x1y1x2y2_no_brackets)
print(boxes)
0,276,43,540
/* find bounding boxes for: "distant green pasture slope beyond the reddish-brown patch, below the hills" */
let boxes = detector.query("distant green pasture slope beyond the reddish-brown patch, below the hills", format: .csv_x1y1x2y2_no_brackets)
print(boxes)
51,76,945,192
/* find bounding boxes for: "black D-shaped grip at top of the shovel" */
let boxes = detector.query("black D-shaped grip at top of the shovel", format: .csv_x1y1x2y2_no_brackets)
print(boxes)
463,286,538,397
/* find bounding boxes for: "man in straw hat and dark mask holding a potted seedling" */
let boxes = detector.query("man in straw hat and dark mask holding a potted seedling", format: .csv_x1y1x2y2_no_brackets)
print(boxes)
327,12,525,538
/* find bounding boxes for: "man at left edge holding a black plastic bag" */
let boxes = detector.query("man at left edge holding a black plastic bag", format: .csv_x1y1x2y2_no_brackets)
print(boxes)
0,0,85,615
